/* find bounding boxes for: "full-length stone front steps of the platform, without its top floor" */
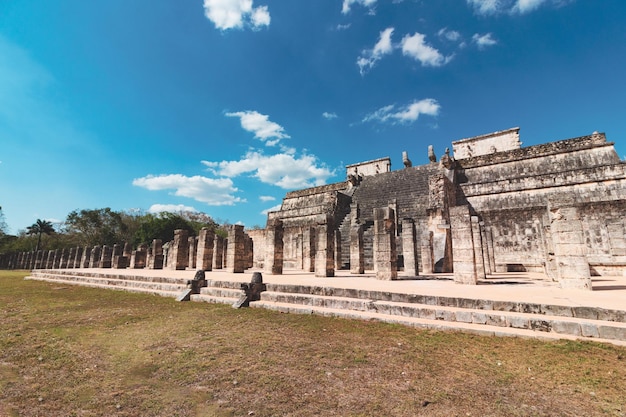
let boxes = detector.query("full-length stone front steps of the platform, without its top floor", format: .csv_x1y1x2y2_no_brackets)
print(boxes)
27,269,626,346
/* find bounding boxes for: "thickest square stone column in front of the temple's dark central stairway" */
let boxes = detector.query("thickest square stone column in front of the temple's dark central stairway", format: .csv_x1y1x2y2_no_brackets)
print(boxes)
373,207,398,280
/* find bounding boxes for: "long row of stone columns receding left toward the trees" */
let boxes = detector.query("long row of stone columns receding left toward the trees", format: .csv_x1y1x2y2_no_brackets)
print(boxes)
0,225,253,273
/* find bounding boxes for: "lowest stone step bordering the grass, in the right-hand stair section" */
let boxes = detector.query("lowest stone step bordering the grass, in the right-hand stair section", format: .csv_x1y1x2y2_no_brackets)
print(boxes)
250,300,626,346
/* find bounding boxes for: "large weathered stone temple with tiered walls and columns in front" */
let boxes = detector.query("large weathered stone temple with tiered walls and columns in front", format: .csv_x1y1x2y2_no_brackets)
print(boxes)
253,128,626,289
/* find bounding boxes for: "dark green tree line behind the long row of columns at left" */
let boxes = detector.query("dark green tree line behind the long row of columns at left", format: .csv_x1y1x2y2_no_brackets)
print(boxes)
0,207,228,253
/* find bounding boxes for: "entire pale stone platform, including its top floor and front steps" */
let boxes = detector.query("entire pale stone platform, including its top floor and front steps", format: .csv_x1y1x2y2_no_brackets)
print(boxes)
27,269,626,346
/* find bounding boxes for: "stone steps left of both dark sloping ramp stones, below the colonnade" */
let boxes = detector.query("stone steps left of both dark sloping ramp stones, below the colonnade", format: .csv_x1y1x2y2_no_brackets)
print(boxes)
26,269,192,298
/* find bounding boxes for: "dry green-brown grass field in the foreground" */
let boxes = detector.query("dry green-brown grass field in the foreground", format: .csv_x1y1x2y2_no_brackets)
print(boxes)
0,271,626,417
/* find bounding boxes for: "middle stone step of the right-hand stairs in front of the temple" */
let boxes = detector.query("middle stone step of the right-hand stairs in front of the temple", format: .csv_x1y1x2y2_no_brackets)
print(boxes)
258,291,626,341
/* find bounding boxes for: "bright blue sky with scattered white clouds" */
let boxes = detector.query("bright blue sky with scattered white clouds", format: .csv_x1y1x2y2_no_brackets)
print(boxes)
0,0,626,233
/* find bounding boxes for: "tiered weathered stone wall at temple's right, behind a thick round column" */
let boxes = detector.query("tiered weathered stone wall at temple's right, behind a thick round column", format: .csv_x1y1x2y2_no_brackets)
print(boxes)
457,133,626,274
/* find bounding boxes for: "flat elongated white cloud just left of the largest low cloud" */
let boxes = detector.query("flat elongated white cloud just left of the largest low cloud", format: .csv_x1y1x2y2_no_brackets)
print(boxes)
133,174,245,206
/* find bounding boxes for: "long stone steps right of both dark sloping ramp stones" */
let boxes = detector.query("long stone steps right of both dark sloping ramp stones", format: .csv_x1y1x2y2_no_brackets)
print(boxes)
250,284,626,346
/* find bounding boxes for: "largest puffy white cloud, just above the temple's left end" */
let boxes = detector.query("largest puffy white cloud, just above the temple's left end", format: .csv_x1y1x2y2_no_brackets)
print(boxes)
202,151,334,189
